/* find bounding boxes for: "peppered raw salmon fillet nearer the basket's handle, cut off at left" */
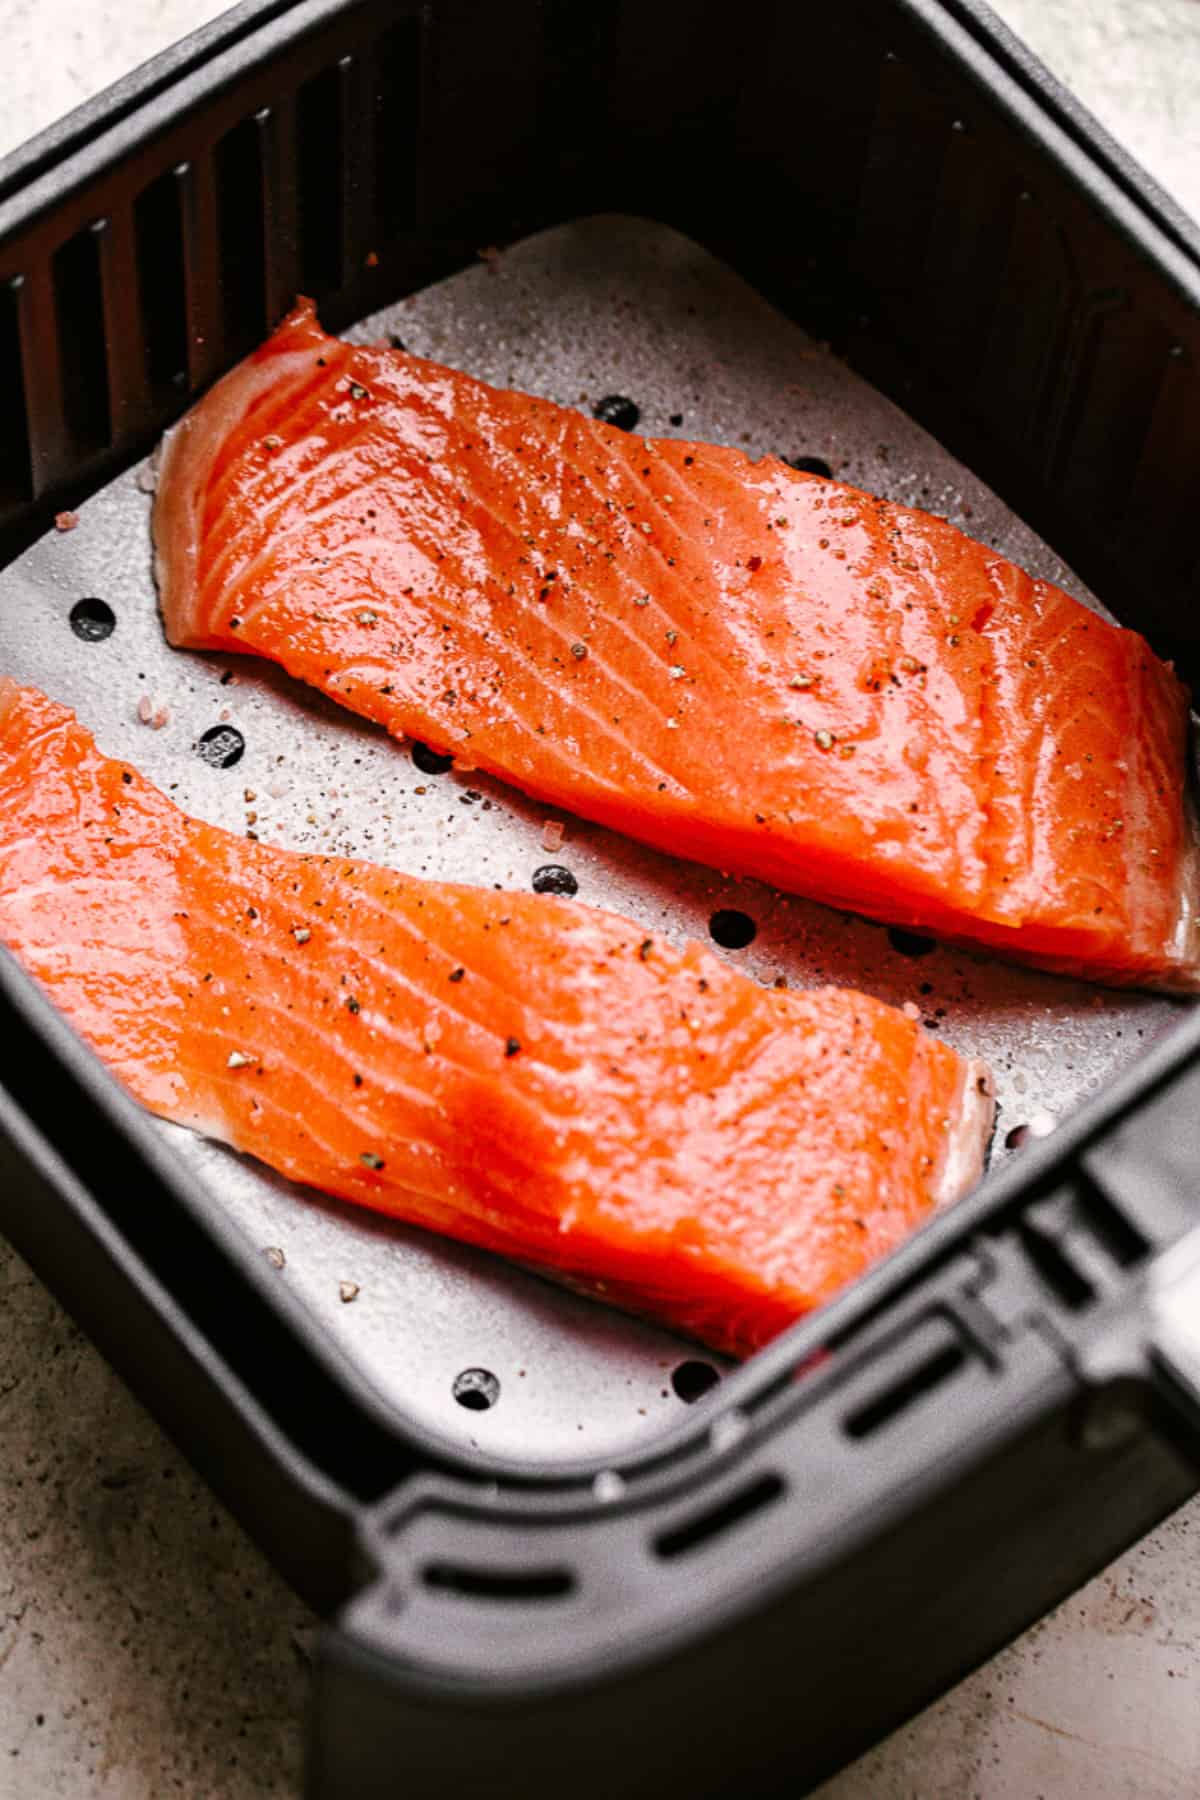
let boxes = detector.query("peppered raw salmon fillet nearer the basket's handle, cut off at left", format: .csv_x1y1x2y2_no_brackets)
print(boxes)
0,680,991,1354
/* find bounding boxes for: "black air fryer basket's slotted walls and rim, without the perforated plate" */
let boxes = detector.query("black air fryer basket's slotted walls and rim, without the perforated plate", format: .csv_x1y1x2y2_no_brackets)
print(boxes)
0,0,1200,1800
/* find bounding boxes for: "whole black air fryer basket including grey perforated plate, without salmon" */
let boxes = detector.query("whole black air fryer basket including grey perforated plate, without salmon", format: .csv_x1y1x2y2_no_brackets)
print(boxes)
0,0,1200,1796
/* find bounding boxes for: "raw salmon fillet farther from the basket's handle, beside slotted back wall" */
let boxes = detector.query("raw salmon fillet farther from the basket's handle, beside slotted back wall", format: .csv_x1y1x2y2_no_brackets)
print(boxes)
155,302,1200,988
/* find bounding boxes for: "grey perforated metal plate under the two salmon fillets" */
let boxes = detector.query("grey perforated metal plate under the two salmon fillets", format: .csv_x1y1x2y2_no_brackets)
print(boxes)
0,218,1178,1462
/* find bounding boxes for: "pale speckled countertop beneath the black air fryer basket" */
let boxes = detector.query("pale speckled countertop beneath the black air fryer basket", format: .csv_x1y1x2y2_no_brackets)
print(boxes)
0,0,1200,1800
